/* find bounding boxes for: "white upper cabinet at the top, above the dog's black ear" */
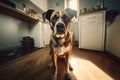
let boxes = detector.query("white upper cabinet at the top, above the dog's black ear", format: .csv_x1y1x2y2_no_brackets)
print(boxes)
30,0,47,11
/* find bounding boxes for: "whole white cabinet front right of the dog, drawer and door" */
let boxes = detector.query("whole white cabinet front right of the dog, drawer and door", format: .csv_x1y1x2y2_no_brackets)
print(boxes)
79,10,105,51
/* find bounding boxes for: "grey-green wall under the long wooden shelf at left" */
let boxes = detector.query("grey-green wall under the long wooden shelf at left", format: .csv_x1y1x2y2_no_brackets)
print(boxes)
0,14,29,50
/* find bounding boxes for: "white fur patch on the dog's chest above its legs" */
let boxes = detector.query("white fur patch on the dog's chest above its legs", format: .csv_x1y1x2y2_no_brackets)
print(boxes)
54,46,70,56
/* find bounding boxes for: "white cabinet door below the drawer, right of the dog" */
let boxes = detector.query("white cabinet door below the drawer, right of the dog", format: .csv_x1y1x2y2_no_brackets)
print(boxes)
80,24,102,50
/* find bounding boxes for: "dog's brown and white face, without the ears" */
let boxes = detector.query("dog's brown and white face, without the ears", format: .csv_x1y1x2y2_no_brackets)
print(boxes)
50,11,70,38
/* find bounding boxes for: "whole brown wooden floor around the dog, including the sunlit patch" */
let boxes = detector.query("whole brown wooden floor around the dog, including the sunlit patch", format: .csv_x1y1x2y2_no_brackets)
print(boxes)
0,47,120,80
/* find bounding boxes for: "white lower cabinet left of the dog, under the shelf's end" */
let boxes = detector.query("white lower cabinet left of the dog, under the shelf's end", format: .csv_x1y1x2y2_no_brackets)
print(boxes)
30,22,51,48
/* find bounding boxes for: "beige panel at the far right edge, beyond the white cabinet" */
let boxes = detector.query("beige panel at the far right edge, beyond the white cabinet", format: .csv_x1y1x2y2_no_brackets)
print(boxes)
106,16,120,57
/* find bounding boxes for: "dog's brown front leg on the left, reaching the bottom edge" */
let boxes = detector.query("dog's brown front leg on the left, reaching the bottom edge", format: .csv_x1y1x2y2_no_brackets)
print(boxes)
52,53,58,80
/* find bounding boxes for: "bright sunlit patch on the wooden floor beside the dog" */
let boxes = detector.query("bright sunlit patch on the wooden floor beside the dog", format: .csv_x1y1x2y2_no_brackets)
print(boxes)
70,57,113,80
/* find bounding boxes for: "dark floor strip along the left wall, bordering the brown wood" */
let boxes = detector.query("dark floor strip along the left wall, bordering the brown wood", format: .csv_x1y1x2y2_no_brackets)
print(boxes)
0,47,40,65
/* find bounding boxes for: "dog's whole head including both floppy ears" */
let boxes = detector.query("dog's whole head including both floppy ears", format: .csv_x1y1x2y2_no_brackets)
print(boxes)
42,8,77,37
